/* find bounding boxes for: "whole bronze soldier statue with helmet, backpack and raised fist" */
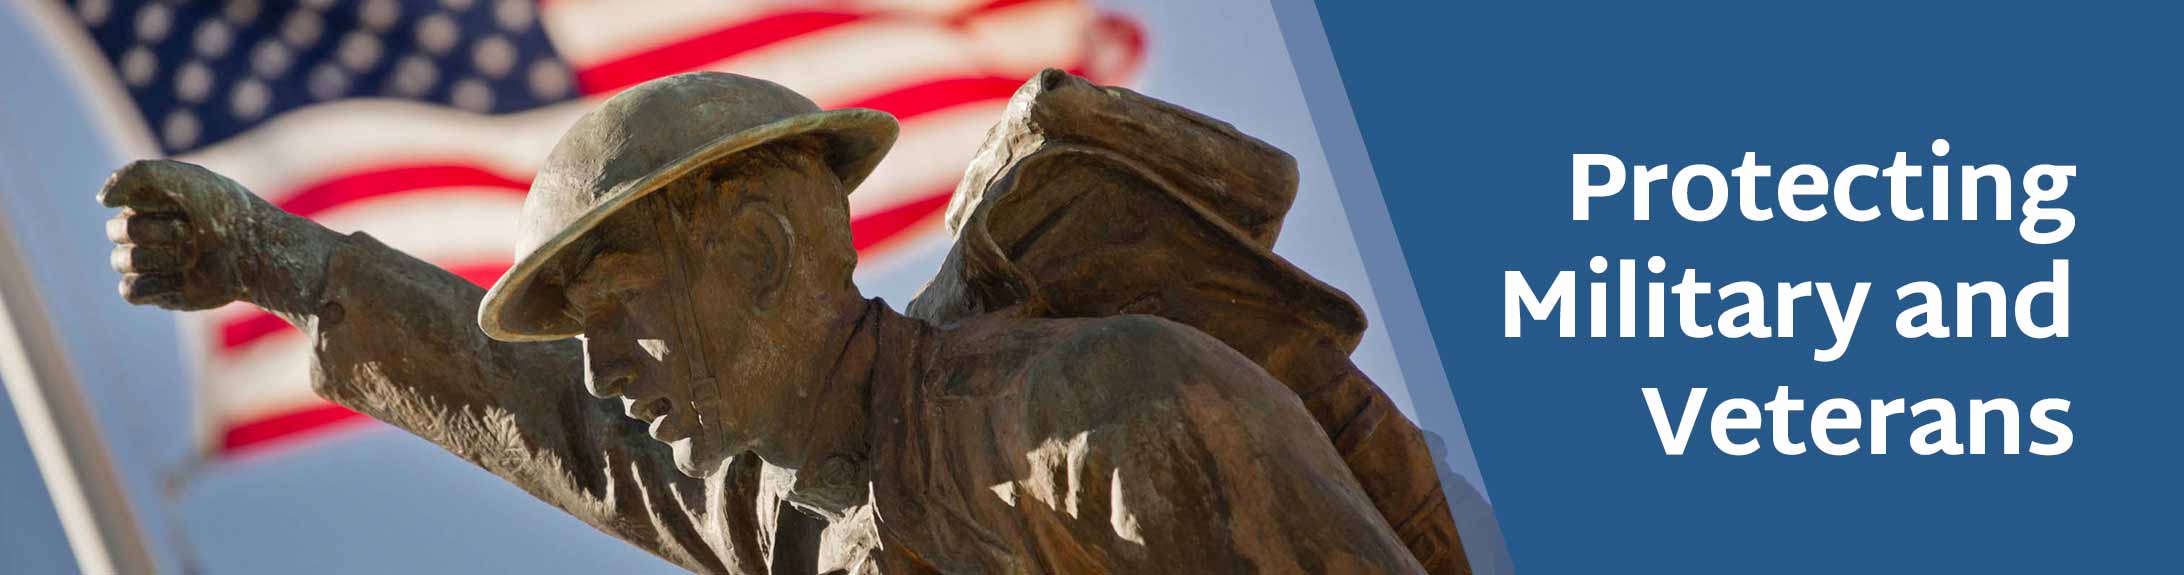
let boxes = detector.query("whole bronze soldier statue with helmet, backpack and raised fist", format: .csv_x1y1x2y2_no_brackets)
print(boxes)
100,70,1470,573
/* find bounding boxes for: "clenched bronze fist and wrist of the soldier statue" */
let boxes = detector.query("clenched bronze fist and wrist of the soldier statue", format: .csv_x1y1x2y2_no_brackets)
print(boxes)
98,160,339,310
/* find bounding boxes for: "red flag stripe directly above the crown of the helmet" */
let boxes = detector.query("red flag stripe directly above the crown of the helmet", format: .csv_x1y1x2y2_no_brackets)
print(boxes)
577,11,869,94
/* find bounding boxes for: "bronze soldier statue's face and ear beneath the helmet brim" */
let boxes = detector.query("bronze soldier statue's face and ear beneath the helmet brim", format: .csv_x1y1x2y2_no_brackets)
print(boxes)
563,153,854,477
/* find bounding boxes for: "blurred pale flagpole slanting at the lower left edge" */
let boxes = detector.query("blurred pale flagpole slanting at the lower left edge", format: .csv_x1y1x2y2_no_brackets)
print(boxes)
0,210,157,573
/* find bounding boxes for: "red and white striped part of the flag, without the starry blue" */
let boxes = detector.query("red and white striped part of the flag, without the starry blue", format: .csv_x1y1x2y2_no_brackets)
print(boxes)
170,0,1142,457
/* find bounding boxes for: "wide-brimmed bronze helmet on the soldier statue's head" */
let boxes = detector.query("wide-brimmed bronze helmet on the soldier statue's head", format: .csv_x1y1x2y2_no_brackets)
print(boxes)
478,72,898,341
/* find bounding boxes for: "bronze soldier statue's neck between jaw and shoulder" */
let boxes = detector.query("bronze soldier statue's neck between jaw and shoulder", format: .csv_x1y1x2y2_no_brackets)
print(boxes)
784,300,924,516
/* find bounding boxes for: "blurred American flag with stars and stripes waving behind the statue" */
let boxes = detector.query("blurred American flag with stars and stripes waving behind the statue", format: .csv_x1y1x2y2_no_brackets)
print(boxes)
33,0,1142,457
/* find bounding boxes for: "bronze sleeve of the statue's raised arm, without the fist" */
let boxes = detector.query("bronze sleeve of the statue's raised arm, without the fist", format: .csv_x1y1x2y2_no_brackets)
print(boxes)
299,234,767,573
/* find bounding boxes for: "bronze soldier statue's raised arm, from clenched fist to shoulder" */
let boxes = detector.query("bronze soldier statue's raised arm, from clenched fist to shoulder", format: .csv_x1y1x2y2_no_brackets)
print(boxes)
100,160,764,573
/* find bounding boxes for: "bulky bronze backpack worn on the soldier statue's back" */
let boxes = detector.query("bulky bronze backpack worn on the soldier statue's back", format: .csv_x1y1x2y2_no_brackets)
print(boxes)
911,70,1470,573
